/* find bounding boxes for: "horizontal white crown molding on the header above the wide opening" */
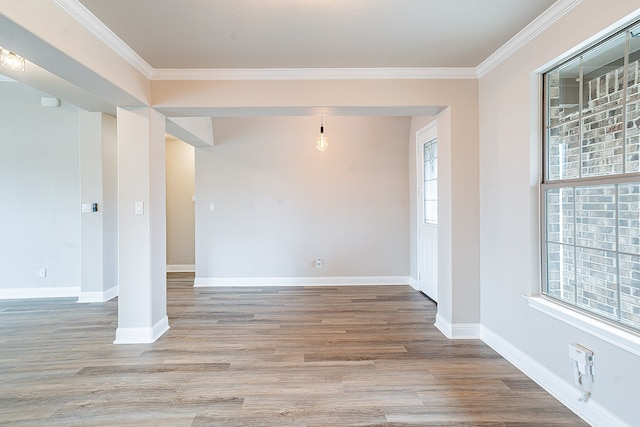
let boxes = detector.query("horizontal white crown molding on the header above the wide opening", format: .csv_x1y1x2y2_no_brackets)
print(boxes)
151,67,478,80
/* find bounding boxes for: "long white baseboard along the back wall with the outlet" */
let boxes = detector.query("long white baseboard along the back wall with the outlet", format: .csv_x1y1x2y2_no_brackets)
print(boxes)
194,276,409,287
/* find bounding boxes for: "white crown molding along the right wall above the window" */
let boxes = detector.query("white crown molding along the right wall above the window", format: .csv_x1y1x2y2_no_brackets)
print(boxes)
476,0,582,78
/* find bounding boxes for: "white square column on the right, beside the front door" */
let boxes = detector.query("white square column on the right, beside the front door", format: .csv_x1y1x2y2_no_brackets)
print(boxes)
435,108,480,339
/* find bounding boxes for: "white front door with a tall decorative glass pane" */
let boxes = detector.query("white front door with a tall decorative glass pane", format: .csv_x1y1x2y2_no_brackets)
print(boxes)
416,122,438,302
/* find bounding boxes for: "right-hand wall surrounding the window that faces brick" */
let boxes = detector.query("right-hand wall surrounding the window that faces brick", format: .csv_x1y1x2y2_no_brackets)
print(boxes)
480,0,640,425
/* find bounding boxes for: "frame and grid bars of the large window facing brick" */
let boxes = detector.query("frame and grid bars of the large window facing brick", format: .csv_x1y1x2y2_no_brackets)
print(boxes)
544,20,640,340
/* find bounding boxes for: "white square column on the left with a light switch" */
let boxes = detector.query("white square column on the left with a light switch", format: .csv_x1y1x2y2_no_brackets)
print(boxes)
114,108,169,344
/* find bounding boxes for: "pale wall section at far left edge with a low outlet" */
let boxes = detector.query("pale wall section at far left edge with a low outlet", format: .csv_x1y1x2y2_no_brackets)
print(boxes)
0,82,80,296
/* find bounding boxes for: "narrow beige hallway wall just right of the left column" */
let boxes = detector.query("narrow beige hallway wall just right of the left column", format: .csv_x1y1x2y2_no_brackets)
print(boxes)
166,137,196,271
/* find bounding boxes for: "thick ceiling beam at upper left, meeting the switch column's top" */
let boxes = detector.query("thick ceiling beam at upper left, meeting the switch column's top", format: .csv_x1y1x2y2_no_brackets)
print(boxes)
0,0,151,106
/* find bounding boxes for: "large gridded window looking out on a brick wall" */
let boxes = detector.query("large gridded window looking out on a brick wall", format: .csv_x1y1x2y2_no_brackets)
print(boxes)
541,23,640,332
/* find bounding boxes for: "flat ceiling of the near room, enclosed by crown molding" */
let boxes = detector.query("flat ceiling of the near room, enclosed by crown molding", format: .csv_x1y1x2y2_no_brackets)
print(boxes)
78,0,555,69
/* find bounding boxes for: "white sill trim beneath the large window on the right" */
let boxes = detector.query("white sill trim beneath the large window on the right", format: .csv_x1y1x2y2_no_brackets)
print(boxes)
525,296,640,356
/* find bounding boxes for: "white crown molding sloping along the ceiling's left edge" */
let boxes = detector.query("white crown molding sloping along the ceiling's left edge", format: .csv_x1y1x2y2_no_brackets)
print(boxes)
55,0,154,79
